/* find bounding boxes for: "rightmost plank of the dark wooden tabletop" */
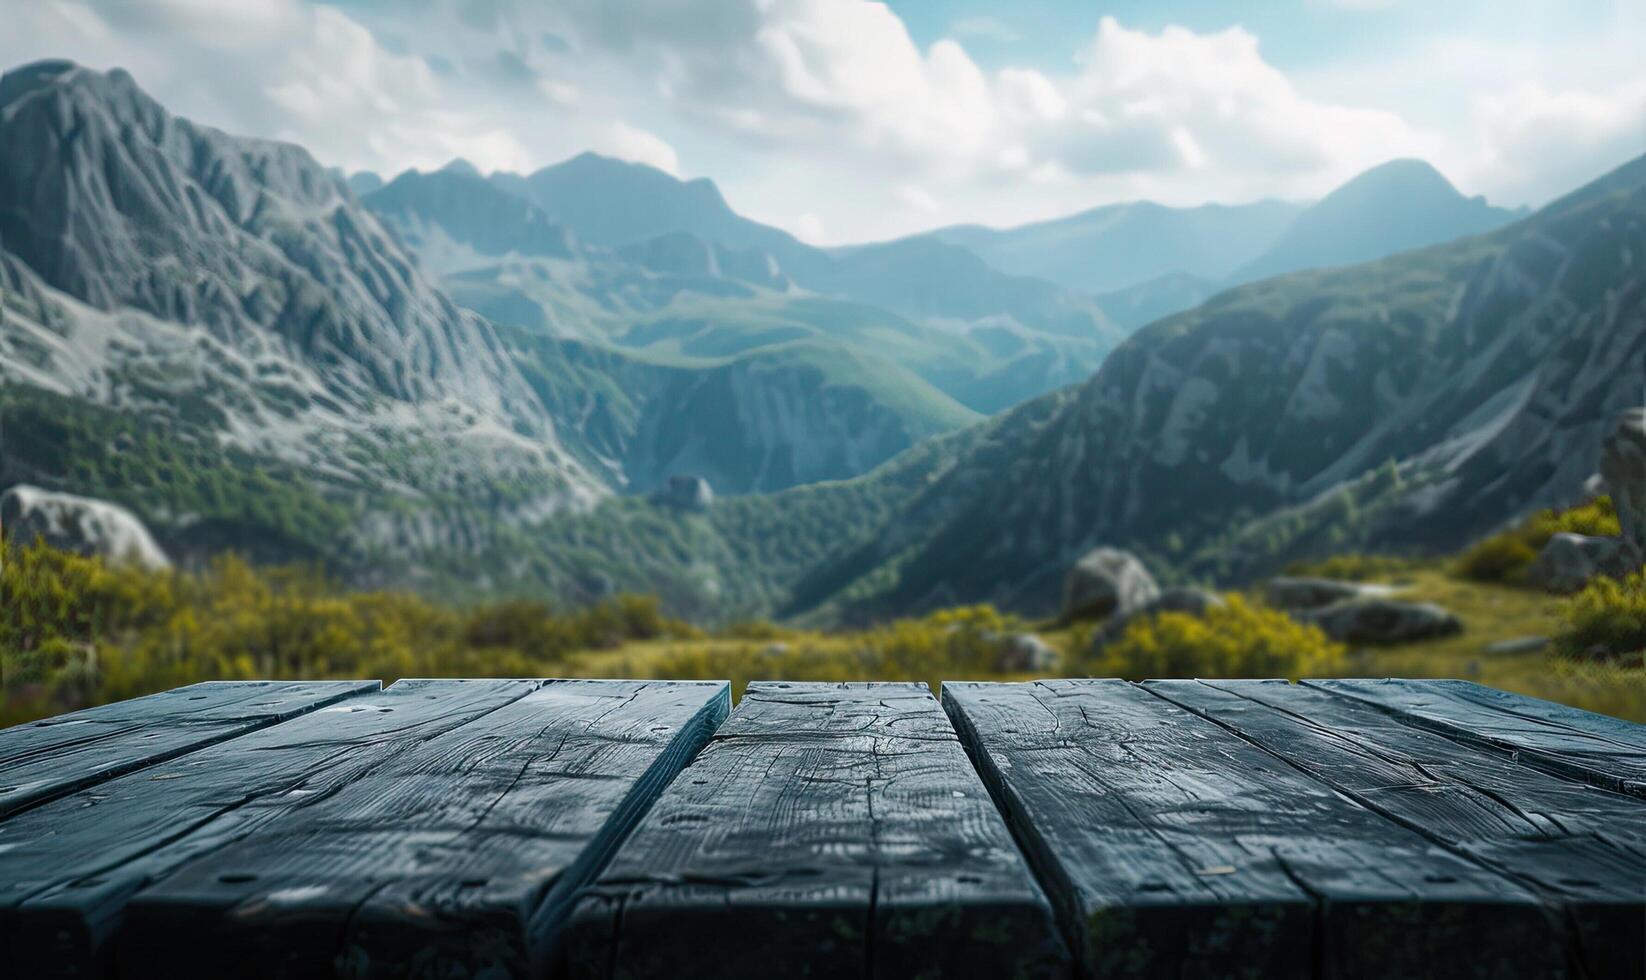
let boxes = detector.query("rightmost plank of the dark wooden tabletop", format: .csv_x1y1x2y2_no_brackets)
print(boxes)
1304,679,1646,797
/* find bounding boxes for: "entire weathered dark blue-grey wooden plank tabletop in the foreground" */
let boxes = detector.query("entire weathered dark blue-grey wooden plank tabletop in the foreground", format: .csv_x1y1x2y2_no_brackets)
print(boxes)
0,679,1646,980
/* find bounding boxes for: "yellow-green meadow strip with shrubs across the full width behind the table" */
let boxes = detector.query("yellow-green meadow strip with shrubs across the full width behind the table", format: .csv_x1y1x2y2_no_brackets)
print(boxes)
0,523,1646,725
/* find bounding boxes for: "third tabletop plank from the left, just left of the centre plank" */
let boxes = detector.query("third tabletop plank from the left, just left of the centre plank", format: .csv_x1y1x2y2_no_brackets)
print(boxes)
120,680,731,977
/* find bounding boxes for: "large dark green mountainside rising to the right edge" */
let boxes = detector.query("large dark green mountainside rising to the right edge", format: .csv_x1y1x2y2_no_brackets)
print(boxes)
788,149,1646,616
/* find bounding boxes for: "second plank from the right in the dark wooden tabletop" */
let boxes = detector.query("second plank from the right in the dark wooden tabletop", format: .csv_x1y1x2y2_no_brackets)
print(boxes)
1146,680,1646,980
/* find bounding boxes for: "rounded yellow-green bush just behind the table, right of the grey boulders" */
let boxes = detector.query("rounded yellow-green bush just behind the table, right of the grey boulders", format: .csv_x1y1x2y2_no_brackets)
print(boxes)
1088,593,1343,680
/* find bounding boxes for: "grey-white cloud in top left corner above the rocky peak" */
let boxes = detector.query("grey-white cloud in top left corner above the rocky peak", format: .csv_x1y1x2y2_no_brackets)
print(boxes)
0,0,530,168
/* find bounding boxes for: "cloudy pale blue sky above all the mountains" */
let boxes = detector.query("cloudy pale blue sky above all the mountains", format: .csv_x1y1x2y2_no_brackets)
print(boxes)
0,0,1646,244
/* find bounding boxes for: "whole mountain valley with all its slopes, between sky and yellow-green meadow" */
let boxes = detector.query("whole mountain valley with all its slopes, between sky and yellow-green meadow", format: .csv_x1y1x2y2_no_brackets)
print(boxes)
0,63,1646,624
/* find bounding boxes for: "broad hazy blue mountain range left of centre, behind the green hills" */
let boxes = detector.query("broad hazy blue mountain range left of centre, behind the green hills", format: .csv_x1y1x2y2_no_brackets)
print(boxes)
362,155,1123,413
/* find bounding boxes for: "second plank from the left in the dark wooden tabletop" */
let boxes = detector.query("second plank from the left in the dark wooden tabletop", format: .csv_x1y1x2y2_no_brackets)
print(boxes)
0,680,538,977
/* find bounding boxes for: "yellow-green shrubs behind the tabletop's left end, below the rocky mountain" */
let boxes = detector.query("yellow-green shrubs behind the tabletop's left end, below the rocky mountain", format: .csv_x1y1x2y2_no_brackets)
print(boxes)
0,542,701,723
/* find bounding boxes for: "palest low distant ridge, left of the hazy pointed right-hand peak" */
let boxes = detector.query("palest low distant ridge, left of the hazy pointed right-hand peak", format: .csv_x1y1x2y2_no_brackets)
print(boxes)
928,201,1302,293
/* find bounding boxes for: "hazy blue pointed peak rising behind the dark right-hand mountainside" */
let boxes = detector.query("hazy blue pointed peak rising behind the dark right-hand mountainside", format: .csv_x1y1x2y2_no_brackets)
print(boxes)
1230,160,1523,282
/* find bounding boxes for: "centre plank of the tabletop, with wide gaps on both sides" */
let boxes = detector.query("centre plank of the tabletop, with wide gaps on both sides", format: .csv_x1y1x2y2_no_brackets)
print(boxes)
565,684,1068,980
